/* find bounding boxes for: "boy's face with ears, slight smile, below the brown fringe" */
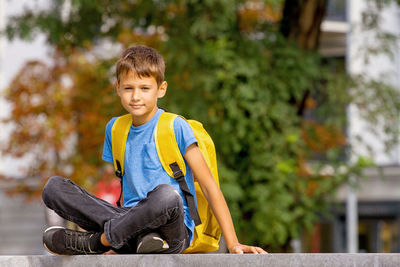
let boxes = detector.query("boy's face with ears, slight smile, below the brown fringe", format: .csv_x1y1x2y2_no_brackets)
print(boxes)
116,71,167,126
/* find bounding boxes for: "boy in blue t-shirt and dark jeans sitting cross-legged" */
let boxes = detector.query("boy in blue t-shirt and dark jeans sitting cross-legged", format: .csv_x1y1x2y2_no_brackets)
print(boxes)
42,46,266,255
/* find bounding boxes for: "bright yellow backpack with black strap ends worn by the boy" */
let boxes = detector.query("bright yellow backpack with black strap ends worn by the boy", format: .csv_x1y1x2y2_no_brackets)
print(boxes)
111,112,221,253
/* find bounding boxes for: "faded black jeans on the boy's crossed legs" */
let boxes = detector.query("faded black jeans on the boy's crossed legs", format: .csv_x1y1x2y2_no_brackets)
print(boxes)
42,176,189,253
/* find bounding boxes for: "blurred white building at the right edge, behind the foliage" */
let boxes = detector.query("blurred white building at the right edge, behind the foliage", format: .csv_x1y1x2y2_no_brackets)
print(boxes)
303,0,400,252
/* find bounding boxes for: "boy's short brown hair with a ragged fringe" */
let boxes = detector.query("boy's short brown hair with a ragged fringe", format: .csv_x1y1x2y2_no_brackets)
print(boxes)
117,45,165,86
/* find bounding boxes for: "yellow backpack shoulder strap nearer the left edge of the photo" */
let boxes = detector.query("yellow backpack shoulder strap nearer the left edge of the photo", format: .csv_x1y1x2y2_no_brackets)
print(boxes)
111,114,132,179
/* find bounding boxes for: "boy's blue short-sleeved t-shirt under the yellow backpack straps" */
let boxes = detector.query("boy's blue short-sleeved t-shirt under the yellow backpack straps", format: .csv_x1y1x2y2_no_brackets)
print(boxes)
103,109,197,245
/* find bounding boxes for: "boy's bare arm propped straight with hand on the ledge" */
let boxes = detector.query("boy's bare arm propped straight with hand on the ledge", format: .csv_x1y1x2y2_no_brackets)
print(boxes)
184,143,266,254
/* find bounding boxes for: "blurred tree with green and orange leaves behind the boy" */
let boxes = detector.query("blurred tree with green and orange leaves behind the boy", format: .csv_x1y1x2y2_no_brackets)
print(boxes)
6,0,399,251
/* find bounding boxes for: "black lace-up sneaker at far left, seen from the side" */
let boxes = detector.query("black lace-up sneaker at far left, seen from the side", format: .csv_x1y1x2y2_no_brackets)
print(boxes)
43,226,108,255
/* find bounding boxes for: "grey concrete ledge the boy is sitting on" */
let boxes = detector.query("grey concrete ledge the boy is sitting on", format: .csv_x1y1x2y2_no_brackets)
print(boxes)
0,253,400,267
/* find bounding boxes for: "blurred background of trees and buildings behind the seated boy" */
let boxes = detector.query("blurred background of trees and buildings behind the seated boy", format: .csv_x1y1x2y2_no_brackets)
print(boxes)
0,0,400,255
